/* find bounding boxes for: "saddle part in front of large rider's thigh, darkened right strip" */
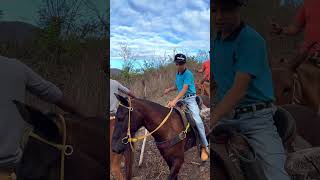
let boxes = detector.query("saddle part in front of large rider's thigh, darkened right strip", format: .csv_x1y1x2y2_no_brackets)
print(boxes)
210,125,266,180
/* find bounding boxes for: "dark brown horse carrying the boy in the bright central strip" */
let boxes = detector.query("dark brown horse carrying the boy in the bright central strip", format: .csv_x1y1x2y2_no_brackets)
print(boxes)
112,95,209,179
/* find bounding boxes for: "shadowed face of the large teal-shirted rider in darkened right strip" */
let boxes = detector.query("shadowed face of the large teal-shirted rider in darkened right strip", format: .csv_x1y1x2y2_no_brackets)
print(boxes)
211,2,240,33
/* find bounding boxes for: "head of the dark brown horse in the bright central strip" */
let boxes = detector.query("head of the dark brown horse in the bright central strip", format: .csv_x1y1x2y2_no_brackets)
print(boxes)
111,94,143,154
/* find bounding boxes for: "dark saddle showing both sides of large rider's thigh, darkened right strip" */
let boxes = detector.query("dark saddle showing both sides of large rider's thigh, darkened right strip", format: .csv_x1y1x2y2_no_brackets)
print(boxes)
211,107,296,180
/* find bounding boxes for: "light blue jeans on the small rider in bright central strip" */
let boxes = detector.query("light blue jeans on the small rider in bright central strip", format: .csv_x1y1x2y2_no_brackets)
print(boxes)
183,96,209,147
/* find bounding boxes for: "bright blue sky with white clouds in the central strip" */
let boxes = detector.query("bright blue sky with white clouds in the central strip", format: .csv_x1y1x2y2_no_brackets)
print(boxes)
110,0,210,68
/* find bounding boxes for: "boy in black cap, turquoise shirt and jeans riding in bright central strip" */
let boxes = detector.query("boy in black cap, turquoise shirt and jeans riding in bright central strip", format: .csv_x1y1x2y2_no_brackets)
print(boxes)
164,54,209,161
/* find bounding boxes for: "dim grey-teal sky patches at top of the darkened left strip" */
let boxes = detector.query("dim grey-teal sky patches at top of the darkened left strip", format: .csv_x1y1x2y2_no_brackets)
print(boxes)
0,0,106,25
